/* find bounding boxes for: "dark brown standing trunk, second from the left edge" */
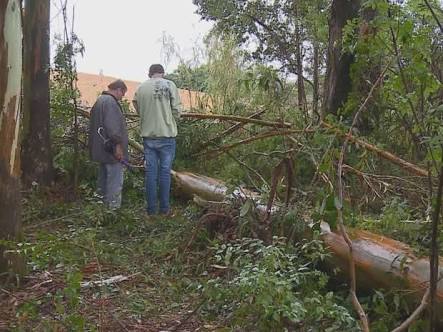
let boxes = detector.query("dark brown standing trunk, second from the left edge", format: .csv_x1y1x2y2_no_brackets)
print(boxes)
21,0,54,186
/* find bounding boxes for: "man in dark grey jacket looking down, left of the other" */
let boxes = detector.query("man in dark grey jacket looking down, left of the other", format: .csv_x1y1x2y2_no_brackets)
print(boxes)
89,80,128,210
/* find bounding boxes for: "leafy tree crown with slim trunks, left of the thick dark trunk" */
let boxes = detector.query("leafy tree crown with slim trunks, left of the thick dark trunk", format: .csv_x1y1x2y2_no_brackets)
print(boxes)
193,0,328,108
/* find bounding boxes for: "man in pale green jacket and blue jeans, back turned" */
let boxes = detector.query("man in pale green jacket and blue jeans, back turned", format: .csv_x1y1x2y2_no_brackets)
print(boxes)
133,64,181,215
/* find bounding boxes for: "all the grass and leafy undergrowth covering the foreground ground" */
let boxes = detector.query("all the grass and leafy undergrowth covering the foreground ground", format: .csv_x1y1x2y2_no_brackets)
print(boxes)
0,180,430,331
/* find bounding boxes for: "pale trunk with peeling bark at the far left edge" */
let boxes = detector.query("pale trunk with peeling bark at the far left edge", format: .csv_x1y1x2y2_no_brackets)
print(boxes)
0,0,22,272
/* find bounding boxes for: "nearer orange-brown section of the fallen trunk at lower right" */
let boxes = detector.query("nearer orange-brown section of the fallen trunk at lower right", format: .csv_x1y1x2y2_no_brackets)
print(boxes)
322,224,443,308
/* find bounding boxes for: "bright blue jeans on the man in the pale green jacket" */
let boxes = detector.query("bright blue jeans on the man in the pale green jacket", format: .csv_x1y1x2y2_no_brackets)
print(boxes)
143,137,175,214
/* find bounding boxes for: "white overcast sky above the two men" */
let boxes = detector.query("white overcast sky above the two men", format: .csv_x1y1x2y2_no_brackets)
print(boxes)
51,0,211,81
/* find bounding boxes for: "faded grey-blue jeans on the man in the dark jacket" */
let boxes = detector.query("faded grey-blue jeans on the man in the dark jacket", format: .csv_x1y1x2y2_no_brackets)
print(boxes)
97,163,123,210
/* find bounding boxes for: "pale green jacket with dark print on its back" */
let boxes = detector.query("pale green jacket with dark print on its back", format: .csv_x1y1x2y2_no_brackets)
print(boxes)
134,77,182,138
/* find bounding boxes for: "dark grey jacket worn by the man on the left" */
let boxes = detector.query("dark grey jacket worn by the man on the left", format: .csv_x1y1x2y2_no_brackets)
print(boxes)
89,91,128,163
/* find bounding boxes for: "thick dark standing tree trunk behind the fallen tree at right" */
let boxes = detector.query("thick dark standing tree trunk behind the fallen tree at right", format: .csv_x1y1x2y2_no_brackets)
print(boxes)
322,0,360,117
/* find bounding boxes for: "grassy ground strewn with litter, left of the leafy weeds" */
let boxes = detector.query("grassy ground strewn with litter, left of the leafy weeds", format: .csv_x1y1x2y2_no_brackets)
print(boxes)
0,191,212,331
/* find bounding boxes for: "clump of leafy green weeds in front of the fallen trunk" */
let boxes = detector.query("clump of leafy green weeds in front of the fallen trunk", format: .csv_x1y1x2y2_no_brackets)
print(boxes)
199,238,358,331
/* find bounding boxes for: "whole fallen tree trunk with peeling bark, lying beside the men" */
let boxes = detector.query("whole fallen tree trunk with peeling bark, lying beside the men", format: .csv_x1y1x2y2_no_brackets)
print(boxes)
172,172,443,320
